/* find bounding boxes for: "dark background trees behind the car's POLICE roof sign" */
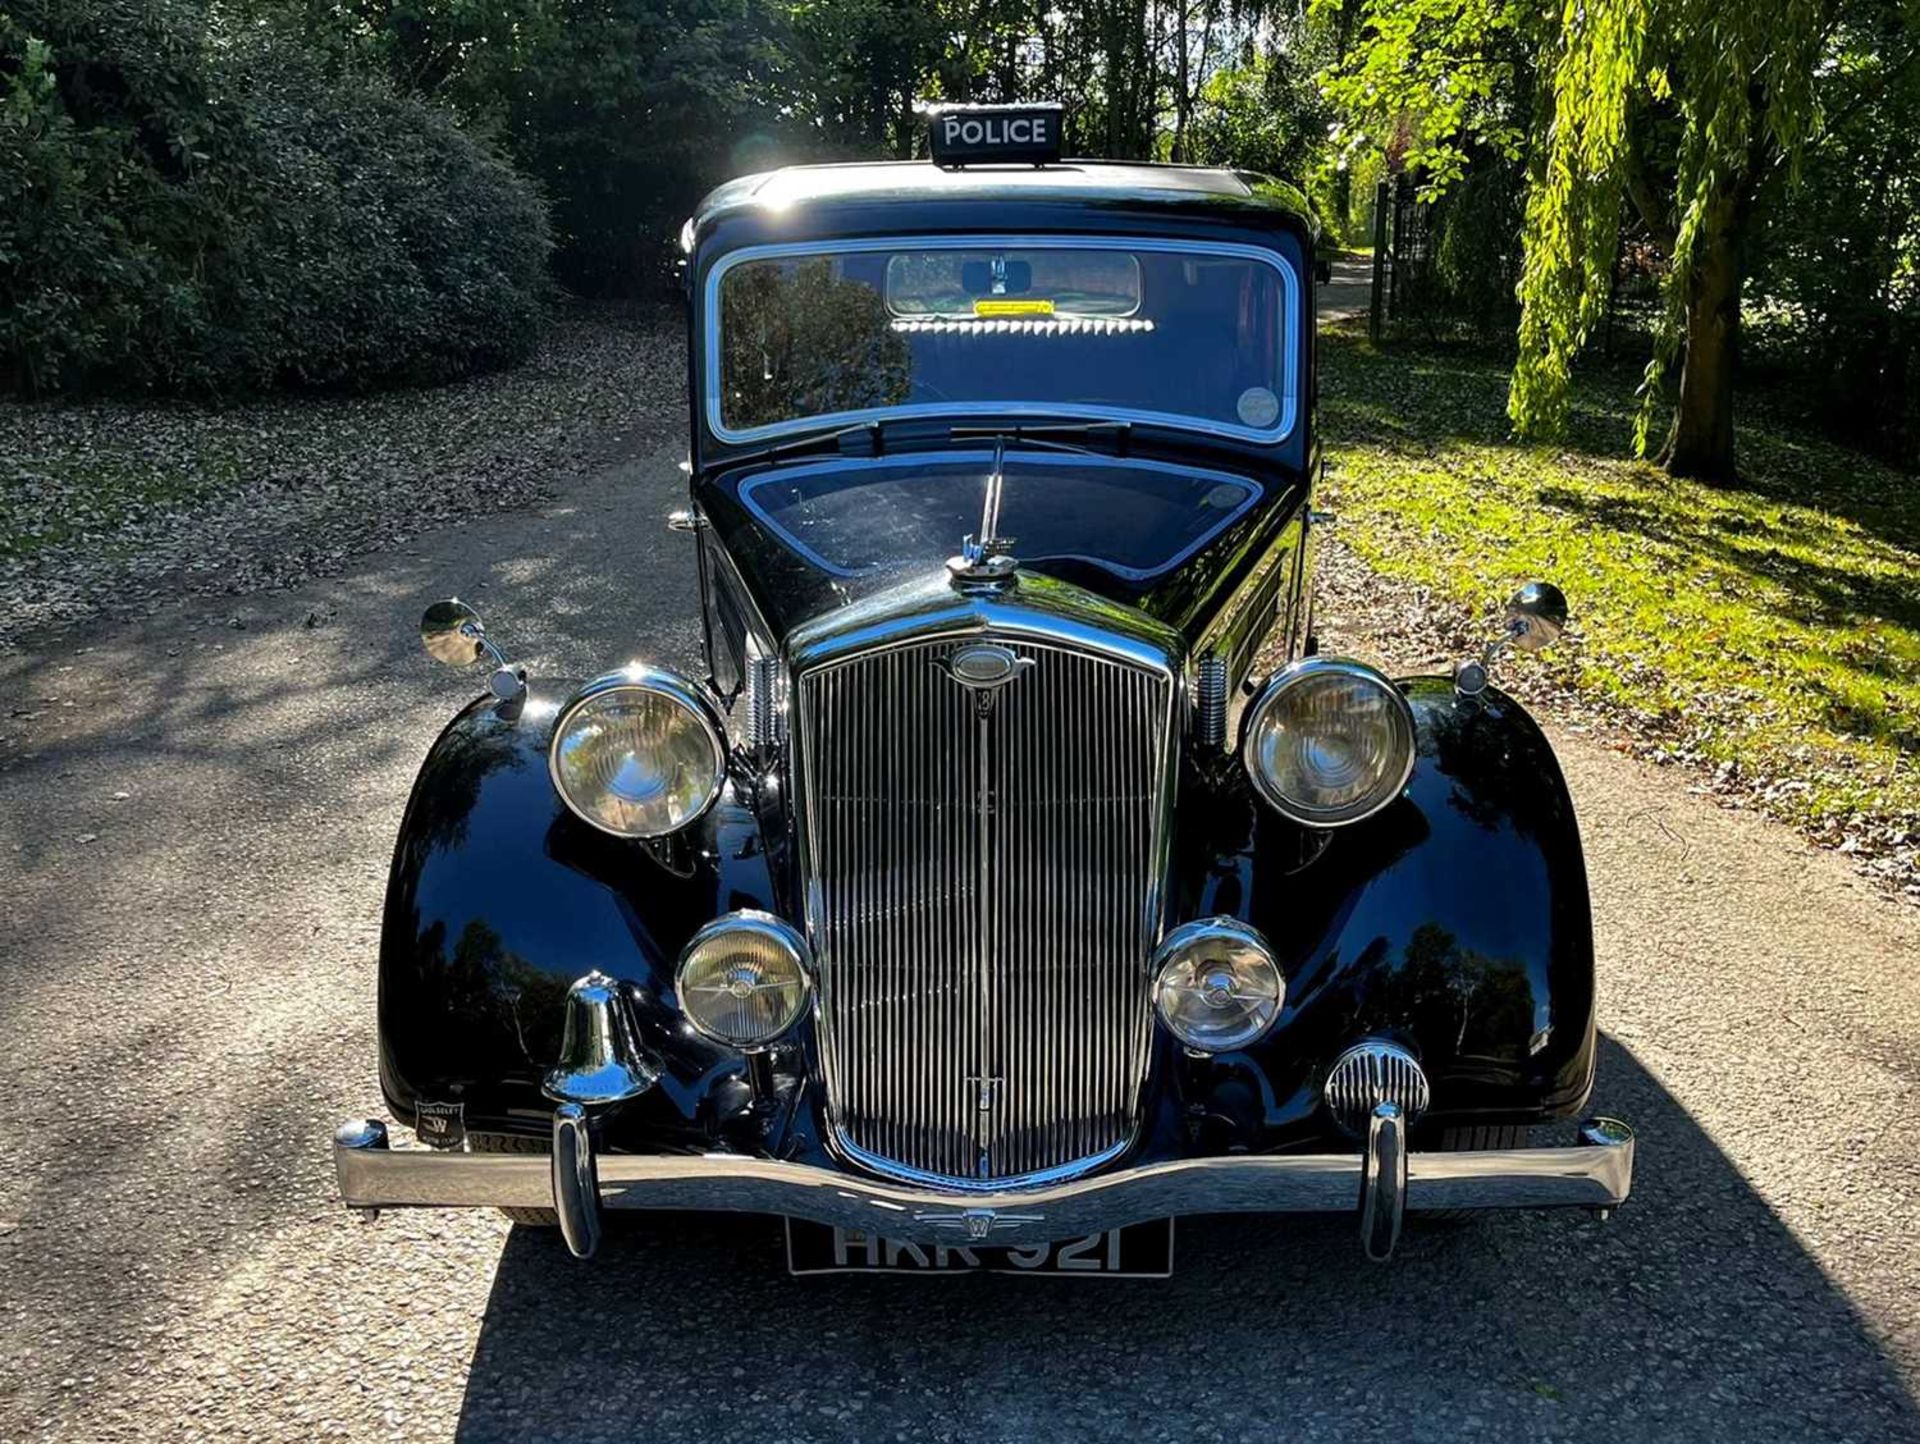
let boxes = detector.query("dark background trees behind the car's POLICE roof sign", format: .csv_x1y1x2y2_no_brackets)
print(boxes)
303,0,1325,294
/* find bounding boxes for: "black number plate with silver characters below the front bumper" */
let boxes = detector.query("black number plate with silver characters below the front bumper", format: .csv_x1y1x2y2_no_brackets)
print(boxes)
787,1219,1173,1279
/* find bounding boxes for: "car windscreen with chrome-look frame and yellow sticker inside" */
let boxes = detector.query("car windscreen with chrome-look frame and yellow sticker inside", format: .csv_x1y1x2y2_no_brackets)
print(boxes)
708,242,1296,440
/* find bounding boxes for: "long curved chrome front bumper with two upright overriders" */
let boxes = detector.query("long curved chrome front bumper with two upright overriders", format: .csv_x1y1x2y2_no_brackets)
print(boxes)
334,1104,1634,1258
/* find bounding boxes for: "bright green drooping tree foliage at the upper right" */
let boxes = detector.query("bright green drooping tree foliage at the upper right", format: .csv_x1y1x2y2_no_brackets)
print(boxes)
1315,0,1920,480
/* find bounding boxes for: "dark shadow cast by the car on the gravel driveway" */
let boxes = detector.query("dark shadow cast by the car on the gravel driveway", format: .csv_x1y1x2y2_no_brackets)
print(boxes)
445,1041,1920,1444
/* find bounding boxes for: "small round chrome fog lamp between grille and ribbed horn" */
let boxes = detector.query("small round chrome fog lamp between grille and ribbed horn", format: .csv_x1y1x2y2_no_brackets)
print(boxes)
1154,918,1286,1052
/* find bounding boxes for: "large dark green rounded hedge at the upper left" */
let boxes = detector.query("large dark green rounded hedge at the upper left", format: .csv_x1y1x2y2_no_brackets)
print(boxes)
0,0,551,394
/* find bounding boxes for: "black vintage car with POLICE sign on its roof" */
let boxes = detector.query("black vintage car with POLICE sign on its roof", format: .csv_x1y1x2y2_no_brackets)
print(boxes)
334,108,1634,1273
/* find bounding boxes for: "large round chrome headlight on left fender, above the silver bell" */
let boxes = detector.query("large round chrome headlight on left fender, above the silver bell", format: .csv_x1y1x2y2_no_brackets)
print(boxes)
547,664,726,837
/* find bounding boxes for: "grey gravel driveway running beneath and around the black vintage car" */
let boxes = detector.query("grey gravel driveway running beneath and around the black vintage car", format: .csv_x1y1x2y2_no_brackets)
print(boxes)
0,362,1920,1444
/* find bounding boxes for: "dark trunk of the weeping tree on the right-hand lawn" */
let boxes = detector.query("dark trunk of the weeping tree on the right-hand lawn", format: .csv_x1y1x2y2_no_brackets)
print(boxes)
1659,194,1745,482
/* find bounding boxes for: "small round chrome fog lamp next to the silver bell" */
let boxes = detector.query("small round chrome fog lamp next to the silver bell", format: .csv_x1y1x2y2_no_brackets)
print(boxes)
674,908,812,1052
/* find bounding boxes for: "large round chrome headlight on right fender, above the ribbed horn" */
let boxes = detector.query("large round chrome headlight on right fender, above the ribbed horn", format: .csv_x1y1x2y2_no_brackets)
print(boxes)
1240,657,1413,828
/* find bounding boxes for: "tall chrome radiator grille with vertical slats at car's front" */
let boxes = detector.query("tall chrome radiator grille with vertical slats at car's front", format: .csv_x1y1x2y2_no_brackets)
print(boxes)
797,639,1173,1181
